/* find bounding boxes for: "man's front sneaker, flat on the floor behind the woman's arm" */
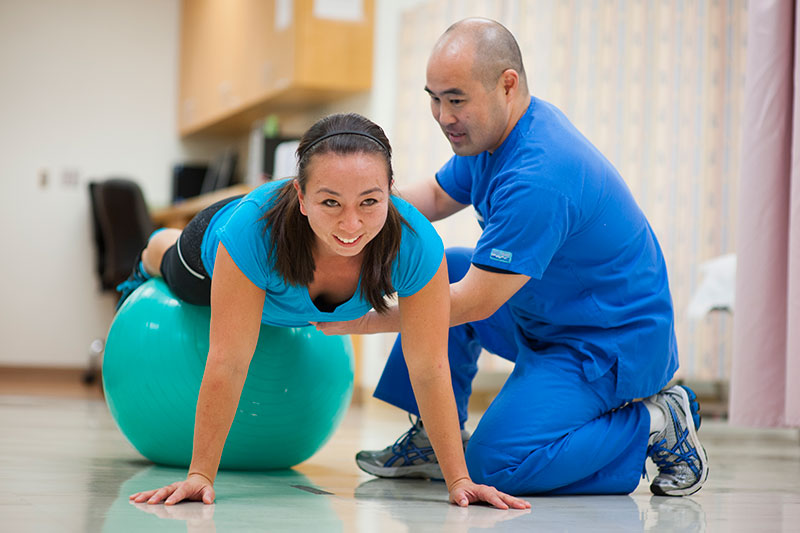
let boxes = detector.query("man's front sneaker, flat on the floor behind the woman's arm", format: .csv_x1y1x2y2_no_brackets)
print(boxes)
356,416,470,479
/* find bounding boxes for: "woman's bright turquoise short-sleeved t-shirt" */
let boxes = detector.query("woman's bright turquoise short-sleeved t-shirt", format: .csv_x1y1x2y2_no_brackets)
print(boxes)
201,180,444,327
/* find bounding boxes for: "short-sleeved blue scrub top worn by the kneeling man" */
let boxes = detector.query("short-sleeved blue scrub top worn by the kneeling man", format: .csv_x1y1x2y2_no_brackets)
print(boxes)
436,98,678,398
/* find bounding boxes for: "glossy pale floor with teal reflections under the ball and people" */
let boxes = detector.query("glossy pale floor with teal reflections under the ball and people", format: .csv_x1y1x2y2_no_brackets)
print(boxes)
0,388,800,533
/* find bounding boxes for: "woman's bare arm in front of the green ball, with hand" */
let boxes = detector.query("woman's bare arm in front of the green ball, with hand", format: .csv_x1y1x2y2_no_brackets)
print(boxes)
131,243,265,505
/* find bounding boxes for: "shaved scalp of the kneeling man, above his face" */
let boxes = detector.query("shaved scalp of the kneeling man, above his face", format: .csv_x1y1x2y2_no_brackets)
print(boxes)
431,18,528,93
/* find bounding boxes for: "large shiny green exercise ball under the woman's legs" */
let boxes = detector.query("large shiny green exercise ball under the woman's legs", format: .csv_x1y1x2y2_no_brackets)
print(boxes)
103,278,353,470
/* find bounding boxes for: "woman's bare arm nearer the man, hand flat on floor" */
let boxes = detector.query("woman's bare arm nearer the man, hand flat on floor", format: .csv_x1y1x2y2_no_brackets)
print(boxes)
399,259,529,509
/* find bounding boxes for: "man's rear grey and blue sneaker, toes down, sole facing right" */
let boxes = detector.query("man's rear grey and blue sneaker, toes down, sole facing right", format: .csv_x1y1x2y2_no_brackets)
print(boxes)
645,385,708,496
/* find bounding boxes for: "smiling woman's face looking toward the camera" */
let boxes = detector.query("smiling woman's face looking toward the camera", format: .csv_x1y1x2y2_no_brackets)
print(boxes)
295,153,390,257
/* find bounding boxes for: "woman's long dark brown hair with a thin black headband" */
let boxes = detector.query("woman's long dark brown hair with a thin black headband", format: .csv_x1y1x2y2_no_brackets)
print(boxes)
263,113,407,312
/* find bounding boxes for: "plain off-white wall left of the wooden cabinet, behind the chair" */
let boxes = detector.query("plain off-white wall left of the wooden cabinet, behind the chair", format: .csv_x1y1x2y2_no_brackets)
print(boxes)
0,0,223,366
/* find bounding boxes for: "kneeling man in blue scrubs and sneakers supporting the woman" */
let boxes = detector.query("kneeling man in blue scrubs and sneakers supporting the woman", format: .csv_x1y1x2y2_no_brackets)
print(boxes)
320,19,708,496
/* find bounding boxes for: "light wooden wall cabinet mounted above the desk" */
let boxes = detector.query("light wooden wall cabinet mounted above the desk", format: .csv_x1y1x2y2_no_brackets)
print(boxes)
178,0,374,136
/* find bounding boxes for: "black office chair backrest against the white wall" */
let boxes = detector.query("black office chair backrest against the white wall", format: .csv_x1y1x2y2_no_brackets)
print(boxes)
89,178,154,290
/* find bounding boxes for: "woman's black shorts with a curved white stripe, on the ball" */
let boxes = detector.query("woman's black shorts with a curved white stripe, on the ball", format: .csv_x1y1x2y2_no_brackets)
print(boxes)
161,195,244,305
